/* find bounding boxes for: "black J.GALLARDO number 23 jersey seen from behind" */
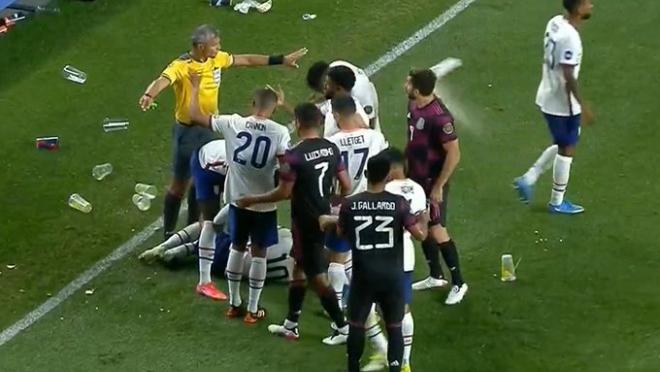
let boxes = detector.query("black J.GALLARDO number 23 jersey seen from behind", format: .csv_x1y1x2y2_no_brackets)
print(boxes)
339,191,411,286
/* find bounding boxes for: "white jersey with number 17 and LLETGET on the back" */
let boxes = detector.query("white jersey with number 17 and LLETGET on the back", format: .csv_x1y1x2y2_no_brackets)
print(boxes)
328,128,387,195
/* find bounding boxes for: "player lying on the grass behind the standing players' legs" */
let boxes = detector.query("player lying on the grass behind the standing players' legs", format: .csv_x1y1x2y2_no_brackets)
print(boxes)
139,206,293,281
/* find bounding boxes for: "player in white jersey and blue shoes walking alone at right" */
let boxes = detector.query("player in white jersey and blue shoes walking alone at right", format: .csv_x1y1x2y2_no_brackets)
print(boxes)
513,0,593,214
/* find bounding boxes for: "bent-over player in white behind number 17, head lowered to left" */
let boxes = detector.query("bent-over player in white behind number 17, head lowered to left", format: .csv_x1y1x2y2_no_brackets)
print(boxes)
307,61,380,131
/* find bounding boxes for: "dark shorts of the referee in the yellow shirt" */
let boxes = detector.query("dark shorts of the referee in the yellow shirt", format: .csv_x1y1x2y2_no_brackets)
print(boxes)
172,122,215,181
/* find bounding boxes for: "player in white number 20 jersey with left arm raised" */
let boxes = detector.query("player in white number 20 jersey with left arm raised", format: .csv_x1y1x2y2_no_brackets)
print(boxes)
190,75,291,324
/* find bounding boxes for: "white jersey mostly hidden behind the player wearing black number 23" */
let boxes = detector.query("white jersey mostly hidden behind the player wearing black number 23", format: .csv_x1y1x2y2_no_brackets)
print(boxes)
385,178,426,272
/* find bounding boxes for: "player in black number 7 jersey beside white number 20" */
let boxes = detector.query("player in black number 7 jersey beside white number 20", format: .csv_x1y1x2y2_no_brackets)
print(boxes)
238,103,350,345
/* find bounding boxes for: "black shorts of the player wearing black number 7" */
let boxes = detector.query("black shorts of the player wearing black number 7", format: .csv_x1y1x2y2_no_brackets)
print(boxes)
291,217,328,278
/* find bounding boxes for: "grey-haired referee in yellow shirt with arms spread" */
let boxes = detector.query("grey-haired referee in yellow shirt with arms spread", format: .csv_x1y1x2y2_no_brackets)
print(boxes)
139,25,307,238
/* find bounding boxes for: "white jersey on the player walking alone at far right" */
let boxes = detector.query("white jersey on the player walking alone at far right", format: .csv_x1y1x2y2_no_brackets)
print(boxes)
536,15,582,116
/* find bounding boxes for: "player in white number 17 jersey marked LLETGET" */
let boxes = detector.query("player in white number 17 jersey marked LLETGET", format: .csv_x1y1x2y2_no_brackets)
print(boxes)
326,96,387,306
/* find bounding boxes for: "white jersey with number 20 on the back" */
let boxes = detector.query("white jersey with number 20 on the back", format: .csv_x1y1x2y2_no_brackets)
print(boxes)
211,114,291,212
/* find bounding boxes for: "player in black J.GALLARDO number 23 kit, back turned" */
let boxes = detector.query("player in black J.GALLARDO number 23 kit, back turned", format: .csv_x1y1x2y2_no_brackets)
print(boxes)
319,152,428,372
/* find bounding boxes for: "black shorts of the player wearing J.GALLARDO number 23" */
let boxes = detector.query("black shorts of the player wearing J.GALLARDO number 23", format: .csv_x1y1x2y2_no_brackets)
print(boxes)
348,271,406,326
